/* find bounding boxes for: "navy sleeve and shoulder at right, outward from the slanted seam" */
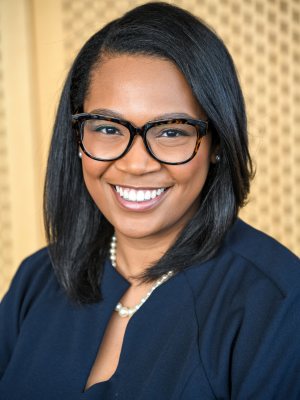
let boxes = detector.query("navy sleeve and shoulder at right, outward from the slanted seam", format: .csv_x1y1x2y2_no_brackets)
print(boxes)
184,219,300,399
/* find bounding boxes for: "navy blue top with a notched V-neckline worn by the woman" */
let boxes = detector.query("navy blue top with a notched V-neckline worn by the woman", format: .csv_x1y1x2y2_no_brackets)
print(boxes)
0,219,300,400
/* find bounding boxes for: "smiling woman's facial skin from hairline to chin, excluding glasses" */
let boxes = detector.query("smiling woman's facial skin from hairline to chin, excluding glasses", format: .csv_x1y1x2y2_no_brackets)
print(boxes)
82,55,216,238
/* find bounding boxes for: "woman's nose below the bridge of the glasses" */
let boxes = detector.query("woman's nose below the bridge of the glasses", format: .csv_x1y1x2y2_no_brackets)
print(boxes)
115,135,161,175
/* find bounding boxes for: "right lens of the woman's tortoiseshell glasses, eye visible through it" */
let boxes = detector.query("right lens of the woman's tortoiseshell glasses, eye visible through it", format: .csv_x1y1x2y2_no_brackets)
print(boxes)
146,124,197,163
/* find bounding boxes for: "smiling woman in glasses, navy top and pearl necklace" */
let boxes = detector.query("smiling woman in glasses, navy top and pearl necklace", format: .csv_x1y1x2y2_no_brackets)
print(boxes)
0,3,300,400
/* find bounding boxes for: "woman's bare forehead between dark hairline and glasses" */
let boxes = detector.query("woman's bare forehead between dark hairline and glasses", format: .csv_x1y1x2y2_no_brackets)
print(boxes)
84,55,203,120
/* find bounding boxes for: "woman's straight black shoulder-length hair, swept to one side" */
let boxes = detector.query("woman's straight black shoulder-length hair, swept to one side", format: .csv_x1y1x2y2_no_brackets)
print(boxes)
44,2,254,304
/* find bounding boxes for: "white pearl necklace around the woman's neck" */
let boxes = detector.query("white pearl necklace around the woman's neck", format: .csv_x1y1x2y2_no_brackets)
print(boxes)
109,235,173,318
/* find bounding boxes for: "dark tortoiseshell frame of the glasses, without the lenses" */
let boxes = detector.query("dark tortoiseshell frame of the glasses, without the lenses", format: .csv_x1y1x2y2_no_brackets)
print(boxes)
72,113,210,165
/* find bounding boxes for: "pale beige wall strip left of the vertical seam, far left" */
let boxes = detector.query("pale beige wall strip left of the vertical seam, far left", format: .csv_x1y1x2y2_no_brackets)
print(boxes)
0,0,42,297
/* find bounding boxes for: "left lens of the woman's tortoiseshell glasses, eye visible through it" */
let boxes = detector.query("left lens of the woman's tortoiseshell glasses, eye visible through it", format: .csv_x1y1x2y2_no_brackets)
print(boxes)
81,119,130,160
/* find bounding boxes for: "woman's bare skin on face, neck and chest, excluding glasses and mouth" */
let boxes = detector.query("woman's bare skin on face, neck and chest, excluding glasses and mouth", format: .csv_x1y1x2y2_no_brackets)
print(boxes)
82,56,218,389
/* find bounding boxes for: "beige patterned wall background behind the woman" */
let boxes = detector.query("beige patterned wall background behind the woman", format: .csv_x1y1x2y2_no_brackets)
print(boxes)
0,0,300,299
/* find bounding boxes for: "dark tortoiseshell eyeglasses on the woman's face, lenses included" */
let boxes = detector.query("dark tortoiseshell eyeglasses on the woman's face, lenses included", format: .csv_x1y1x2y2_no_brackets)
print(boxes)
72,114,209,165
